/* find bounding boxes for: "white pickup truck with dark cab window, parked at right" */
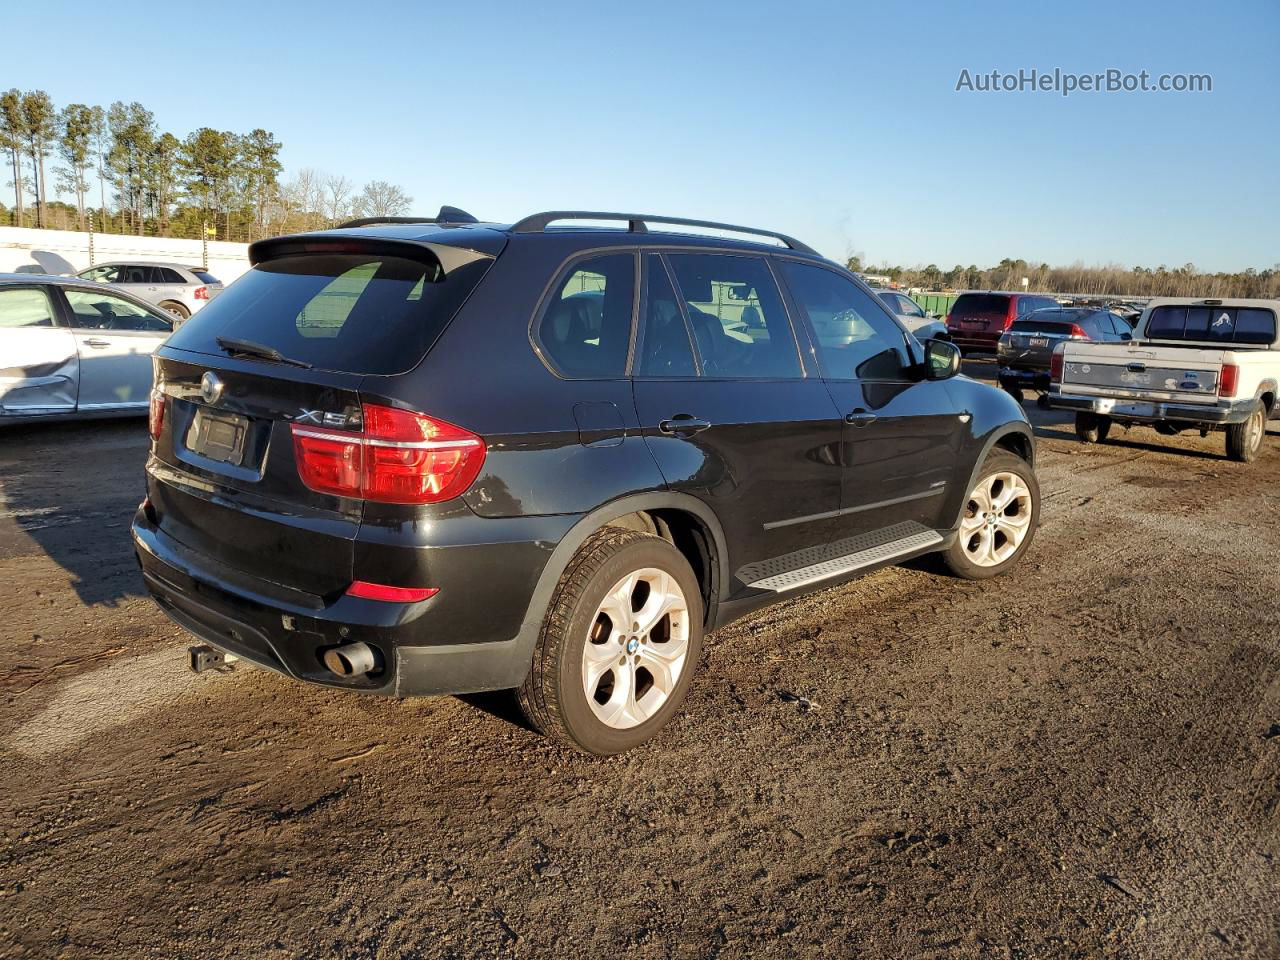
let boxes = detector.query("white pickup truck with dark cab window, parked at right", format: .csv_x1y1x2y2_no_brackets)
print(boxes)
1048,300,1280,462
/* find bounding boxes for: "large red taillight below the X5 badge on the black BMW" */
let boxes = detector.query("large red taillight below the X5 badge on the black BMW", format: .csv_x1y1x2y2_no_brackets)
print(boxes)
293,403,485,503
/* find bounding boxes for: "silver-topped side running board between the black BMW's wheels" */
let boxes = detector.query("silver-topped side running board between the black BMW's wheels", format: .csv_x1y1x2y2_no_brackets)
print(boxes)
737,522,942,593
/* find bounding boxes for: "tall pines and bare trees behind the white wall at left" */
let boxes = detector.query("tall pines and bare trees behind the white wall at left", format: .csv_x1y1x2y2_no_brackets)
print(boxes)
0,90,412,241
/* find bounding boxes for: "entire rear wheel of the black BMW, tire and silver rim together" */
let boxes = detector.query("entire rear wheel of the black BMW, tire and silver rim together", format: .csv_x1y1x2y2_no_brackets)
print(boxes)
517,527,703,756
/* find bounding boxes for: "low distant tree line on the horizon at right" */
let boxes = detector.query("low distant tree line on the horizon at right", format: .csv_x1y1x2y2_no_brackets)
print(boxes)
847,256,1280,300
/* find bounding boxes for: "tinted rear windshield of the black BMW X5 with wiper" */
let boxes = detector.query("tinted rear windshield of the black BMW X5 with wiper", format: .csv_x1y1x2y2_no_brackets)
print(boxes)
169,253,490,374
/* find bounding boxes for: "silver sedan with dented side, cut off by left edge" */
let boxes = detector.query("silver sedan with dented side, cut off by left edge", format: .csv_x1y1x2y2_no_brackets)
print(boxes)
0,274,174,425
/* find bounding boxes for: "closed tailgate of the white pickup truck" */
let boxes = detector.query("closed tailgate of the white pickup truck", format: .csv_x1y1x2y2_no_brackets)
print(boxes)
1062,344,1222,403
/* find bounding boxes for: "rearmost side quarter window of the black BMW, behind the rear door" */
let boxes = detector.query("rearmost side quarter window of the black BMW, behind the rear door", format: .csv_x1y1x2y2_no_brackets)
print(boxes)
535,253,636,380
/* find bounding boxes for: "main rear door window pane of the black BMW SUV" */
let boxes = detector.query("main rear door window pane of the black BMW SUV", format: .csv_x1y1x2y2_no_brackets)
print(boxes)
668,253,804,380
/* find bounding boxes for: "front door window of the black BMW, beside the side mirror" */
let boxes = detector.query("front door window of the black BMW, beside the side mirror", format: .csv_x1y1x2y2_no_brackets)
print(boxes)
782,261,911,380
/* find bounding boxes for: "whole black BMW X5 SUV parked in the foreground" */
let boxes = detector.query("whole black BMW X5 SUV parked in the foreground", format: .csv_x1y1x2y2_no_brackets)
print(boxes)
133,207,1039,754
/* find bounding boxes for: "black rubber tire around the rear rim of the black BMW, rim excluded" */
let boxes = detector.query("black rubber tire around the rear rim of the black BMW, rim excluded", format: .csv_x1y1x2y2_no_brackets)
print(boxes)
516,527,703,756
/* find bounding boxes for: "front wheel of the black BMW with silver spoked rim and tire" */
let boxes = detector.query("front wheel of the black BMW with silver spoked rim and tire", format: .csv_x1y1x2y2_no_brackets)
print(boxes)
942,451,1039,580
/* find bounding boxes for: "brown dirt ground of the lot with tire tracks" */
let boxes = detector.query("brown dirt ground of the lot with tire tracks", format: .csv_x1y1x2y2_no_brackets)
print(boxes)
0,365,1280,957
